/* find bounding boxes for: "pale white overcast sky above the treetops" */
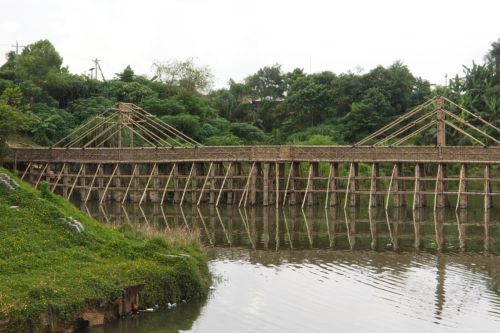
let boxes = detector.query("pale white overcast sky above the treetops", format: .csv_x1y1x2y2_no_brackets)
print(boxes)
0,0,500,87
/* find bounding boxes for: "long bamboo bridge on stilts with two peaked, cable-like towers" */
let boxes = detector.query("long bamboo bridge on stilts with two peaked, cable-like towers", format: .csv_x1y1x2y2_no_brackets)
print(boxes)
4,96,500,210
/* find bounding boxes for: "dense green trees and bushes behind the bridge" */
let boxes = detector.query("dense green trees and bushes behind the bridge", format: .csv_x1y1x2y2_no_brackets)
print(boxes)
0,40,500,145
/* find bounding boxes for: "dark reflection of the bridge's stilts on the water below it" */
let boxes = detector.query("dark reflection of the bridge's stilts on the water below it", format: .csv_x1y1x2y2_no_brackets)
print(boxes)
82,203,500,253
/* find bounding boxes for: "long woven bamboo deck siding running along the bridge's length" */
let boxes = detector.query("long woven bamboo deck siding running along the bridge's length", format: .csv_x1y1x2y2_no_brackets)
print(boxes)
5,146,500,164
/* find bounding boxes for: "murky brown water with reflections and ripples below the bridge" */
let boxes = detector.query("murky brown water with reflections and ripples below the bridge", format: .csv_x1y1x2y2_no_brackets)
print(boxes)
88,204,500,333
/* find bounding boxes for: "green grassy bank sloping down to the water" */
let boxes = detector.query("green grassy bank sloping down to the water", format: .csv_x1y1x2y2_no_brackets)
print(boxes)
0,169,210,331
